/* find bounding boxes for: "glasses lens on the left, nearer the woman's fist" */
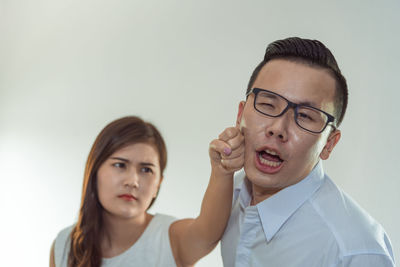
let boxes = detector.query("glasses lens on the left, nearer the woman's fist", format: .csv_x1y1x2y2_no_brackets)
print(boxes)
255,91,287,116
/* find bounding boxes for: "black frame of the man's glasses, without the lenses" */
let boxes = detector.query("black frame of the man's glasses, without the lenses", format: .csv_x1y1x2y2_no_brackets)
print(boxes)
246,88,336,134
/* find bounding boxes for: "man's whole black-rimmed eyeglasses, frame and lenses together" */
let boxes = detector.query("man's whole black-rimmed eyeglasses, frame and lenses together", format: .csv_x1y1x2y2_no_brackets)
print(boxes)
246,88,336,133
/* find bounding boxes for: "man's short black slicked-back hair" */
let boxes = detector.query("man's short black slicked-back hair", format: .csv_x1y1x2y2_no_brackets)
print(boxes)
246,37,348,126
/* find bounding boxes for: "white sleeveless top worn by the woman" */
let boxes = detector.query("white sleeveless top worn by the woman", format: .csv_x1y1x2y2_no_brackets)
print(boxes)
54,213,176,267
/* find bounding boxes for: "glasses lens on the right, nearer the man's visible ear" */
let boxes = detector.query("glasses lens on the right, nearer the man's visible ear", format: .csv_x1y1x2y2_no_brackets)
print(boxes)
296,106,328,132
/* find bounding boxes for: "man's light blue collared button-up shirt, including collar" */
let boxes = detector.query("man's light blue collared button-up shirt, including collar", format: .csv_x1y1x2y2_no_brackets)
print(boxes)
221,162,395,267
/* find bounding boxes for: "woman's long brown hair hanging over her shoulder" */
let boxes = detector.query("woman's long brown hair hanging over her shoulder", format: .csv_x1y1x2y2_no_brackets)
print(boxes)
68,116,167,267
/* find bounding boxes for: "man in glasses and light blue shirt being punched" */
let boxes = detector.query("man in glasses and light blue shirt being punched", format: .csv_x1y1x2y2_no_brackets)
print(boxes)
221,38,394,267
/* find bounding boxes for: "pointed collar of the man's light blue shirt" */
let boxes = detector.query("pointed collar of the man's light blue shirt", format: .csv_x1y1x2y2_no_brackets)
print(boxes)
235,161,324,242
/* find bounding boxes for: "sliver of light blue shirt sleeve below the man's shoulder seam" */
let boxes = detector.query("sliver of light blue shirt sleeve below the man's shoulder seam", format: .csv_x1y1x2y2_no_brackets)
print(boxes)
336,254,396,267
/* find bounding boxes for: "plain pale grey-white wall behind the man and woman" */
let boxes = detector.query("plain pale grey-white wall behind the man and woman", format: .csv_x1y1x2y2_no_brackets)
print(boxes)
0,0,400,266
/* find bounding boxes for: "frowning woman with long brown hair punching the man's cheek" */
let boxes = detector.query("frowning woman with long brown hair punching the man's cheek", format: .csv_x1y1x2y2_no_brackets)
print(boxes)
50,116,244,267
